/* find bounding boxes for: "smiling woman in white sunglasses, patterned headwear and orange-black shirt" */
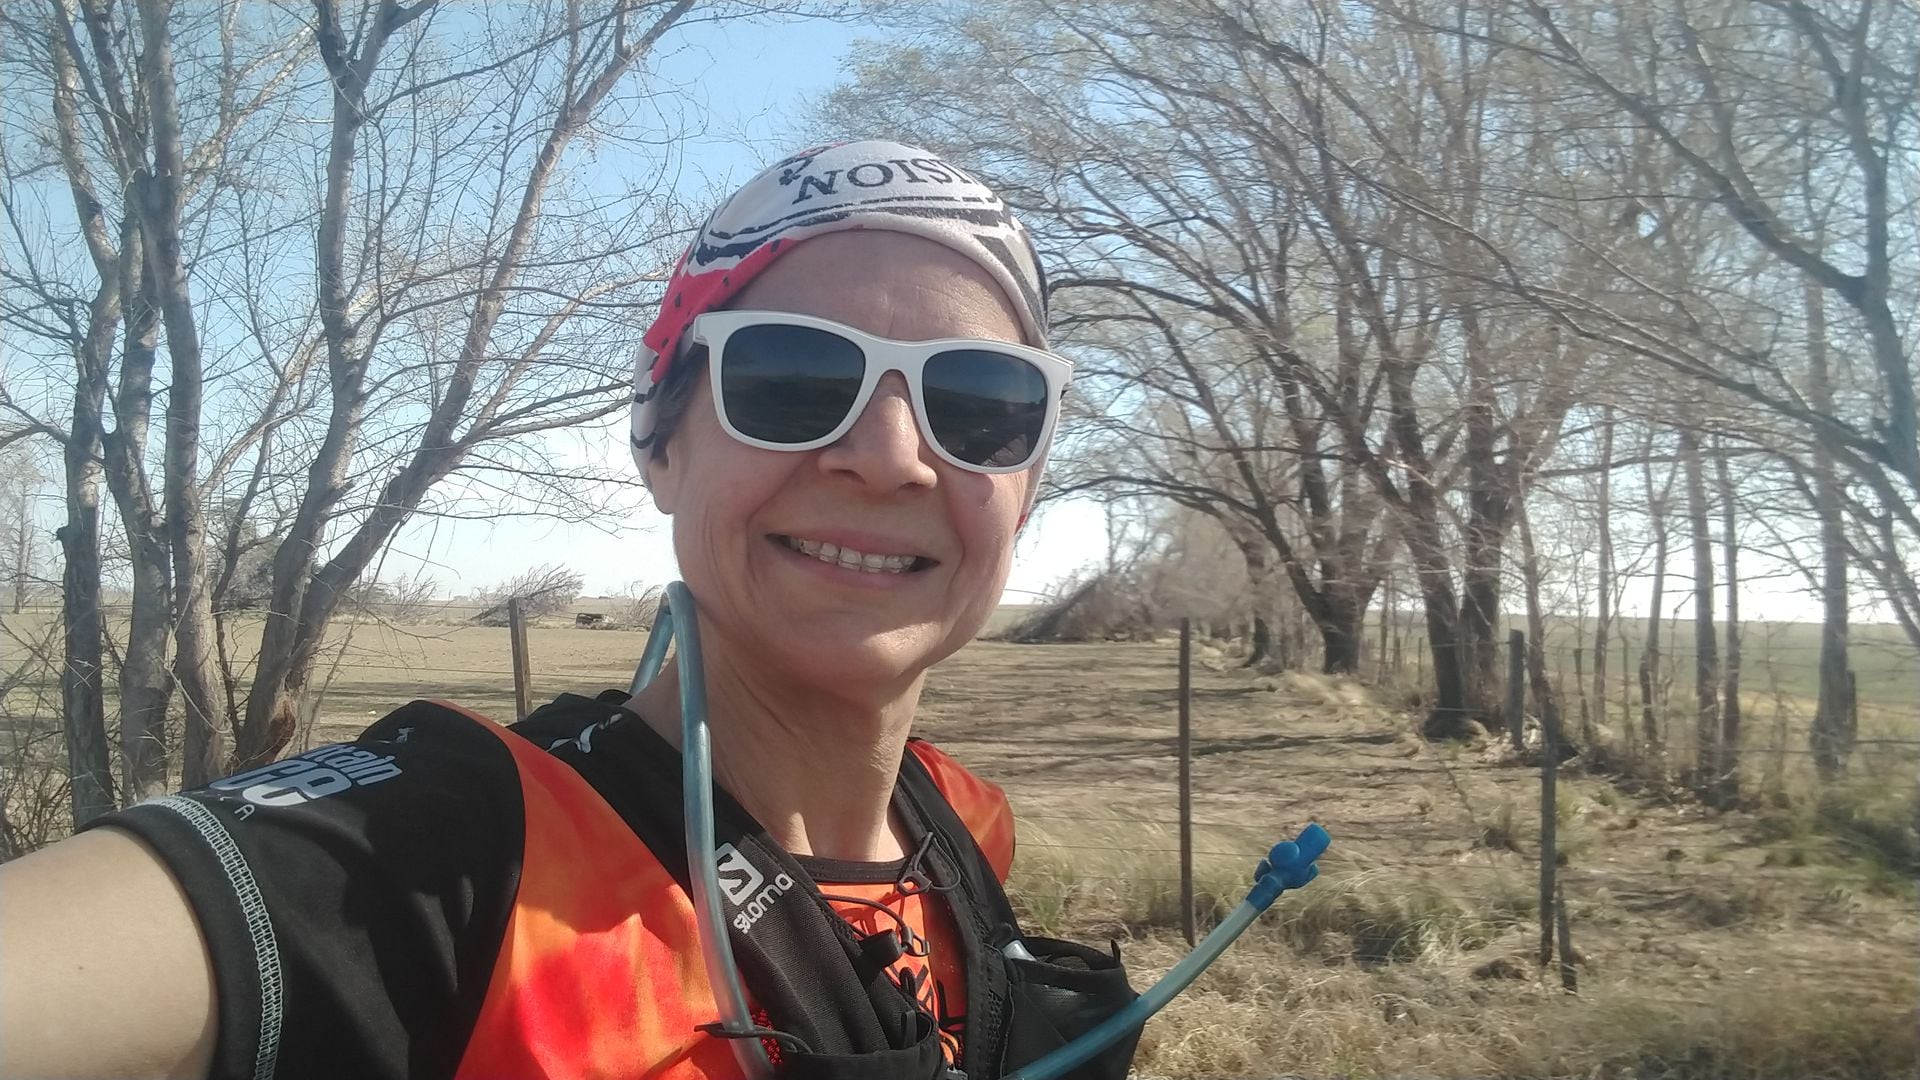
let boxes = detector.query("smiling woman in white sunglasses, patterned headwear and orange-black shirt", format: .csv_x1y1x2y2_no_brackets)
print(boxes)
0,142,1135,1080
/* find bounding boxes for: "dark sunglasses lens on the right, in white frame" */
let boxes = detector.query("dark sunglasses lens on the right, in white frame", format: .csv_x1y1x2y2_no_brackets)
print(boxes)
922,348,1048,467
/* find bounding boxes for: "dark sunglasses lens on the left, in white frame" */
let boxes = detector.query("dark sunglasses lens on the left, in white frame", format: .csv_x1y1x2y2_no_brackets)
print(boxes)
720,325,866,444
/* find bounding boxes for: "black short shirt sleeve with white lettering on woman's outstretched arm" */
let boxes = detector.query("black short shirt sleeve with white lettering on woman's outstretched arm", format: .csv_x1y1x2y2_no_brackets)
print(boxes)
92,701,524,1080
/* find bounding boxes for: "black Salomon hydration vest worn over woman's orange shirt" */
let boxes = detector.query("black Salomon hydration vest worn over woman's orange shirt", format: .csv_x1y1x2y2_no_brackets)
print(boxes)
511,690,1139,1080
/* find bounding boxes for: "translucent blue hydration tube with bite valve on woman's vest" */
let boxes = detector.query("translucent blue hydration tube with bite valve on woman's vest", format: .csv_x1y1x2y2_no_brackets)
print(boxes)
632,580,1332,1080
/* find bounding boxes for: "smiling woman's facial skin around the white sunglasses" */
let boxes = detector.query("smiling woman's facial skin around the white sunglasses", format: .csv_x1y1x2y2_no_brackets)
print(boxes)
649,231,1035,694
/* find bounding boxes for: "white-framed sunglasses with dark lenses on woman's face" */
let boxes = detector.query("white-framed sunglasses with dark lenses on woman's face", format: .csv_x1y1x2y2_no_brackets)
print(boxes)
689,311,1073,473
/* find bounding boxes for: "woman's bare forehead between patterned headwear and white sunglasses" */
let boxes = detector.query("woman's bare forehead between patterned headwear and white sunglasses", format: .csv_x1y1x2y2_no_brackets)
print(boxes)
728,229,1025,342
